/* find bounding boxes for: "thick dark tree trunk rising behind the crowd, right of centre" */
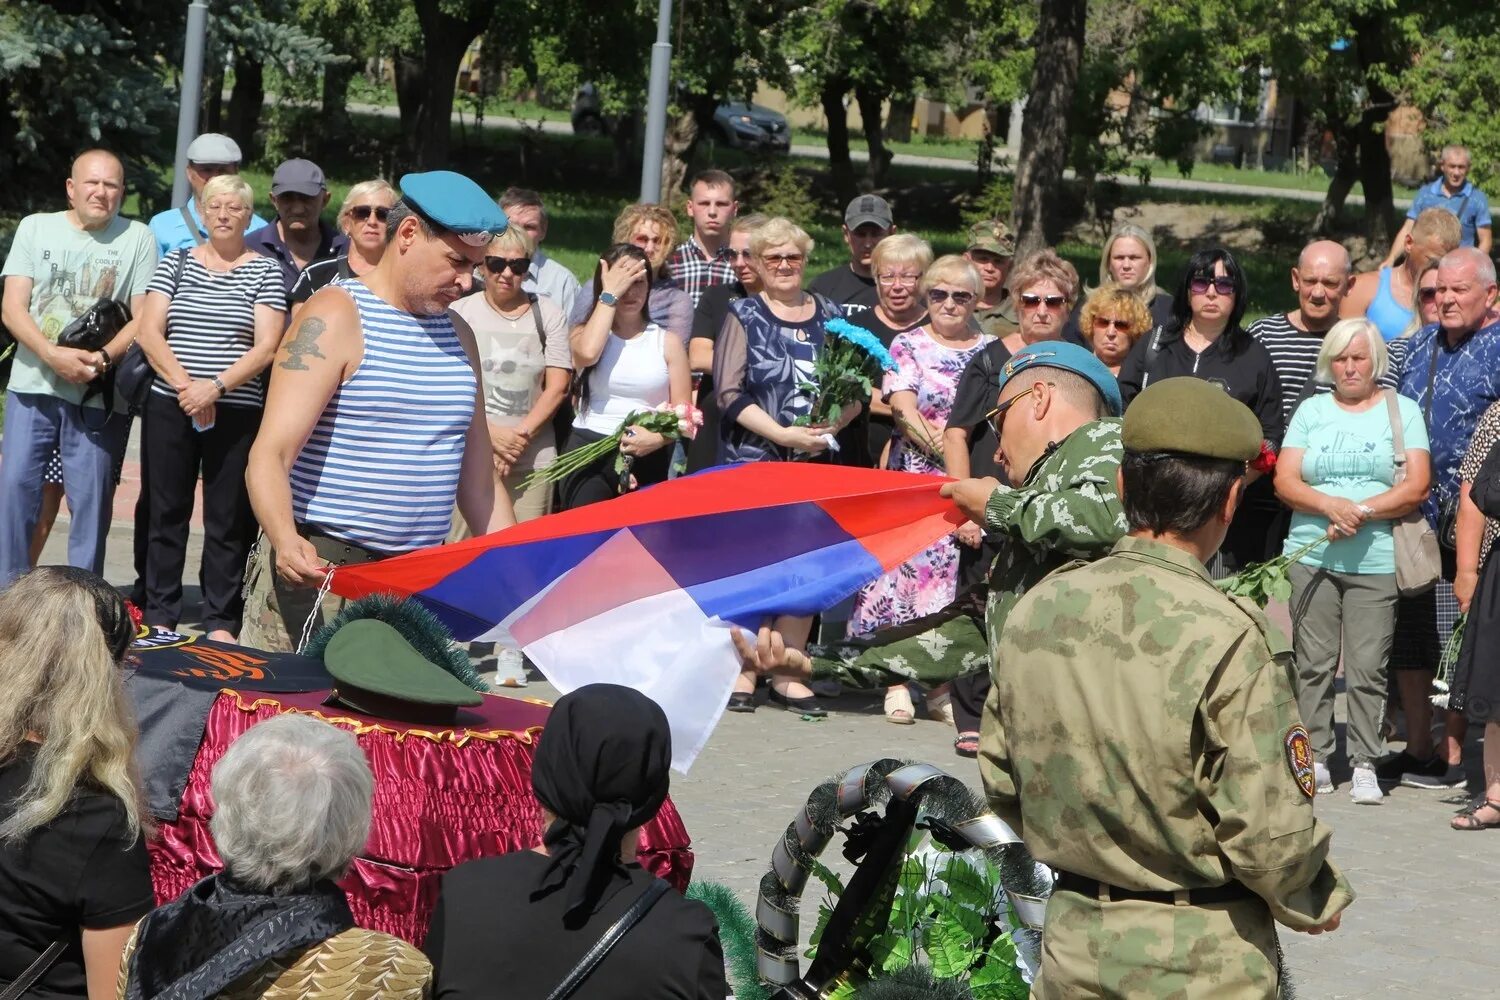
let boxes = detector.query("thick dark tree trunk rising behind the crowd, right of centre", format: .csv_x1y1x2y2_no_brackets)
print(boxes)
1013,0,1089,258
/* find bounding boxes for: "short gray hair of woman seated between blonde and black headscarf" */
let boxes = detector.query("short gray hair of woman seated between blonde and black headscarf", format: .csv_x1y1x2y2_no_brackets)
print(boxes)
209,715,375,895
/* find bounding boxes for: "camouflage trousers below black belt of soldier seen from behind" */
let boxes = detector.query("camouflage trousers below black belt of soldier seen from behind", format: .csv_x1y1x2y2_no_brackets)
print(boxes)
1031,891,1281,1000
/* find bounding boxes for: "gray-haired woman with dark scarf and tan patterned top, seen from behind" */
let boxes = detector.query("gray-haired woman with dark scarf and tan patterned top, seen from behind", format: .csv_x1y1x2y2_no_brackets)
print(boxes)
119,715,432,1000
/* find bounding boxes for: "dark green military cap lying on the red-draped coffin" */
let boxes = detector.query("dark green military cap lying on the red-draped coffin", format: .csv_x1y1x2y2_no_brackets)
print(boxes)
323,618,485,721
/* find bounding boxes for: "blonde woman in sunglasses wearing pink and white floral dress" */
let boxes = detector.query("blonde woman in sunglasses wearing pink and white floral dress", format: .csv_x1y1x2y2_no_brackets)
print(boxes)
849,256,993,726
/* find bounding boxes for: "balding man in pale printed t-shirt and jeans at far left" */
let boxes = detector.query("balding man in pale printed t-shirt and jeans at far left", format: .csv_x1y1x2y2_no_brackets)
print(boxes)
0,150,156,588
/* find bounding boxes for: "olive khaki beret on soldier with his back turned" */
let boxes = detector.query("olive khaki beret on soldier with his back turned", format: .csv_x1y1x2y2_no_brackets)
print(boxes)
1121,375,1263,462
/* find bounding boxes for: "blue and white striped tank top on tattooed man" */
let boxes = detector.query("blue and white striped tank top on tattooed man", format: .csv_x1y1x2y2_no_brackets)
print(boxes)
291,280,477,553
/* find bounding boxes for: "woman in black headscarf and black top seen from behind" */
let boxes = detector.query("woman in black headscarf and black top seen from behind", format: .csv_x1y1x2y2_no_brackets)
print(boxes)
425,684,729,1000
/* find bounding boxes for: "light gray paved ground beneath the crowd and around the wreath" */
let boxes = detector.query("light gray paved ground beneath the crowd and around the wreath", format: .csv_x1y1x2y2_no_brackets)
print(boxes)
45,503,1500,1000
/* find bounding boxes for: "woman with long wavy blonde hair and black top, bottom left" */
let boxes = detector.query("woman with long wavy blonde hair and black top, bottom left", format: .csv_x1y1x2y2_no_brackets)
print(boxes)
0,567,155,1000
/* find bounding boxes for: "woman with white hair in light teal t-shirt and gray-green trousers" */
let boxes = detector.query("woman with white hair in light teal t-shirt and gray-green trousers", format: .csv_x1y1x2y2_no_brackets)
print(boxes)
1277,319,1433,805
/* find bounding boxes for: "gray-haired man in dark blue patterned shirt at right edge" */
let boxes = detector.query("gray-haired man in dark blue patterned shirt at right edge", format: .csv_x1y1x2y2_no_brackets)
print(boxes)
1376,247,1500,789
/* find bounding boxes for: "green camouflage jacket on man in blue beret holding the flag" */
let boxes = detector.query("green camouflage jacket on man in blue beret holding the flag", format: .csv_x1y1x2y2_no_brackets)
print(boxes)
984,418,1125,651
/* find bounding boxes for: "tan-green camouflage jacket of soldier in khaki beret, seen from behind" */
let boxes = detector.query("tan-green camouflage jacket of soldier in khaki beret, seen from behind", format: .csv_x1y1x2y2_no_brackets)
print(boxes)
980,537,1353,930
